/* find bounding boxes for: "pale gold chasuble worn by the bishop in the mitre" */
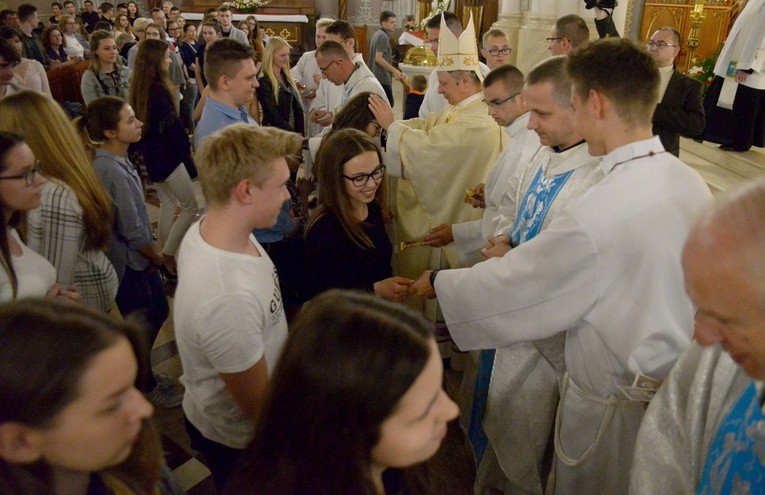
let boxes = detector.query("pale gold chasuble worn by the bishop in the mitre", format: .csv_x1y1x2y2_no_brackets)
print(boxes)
385,92,509,319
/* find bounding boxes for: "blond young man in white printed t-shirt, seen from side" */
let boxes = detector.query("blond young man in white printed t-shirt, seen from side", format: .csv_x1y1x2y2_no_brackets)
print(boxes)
173,124,301,492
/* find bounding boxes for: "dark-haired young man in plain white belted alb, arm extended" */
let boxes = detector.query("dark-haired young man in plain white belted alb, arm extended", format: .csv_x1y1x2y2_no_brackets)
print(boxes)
413,38,711,494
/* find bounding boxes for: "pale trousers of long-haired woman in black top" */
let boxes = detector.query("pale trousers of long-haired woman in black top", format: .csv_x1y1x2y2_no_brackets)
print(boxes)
155,163,199,256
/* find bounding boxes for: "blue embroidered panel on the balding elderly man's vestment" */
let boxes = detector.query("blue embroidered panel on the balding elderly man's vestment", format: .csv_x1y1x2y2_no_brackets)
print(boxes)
696,382,765,495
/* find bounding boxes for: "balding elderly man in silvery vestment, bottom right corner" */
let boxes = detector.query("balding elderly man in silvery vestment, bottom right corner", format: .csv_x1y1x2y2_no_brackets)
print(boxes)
630,178,765,495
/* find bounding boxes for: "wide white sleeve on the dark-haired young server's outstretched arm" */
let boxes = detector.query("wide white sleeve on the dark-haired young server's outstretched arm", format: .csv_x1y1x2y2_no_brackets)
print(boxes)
435,212,598,350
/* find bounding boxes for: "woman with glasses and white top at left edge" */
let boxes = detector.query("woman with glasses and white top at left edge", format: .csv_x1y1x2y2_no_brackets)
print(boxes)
0,132,80,301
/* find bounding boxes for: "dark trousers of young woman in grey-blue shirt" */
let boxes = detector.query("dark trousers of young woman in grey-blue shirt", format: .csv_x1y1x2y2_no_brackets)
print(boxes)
115,267,170,392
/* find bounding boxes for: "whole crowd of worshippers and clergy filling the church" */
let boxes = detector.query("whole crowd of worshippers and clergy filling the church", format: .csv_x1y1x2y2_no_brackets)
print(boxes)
0,0,765,494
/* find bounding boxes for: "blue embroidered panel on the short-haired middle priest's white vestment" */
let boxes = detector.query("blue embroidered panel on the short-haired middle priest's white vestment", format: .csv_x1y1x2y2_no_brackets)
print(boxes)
468,158,574,466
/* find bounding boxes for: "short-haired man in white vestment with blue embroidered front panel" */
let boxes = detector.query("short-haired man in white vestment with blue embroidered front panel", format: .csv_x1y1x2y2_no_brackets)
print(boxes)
463,57,605,495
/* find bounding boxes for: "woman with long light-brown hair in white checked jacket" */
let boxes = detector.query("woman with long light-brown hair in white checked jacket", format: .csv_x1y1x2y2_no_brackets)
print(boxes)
0,91,119,311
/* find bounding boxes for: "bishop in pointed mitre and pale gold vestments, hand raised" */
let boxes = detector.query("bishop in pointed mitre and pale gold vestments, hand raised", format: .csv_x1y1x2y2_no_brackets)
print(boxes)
369,15,509,319
